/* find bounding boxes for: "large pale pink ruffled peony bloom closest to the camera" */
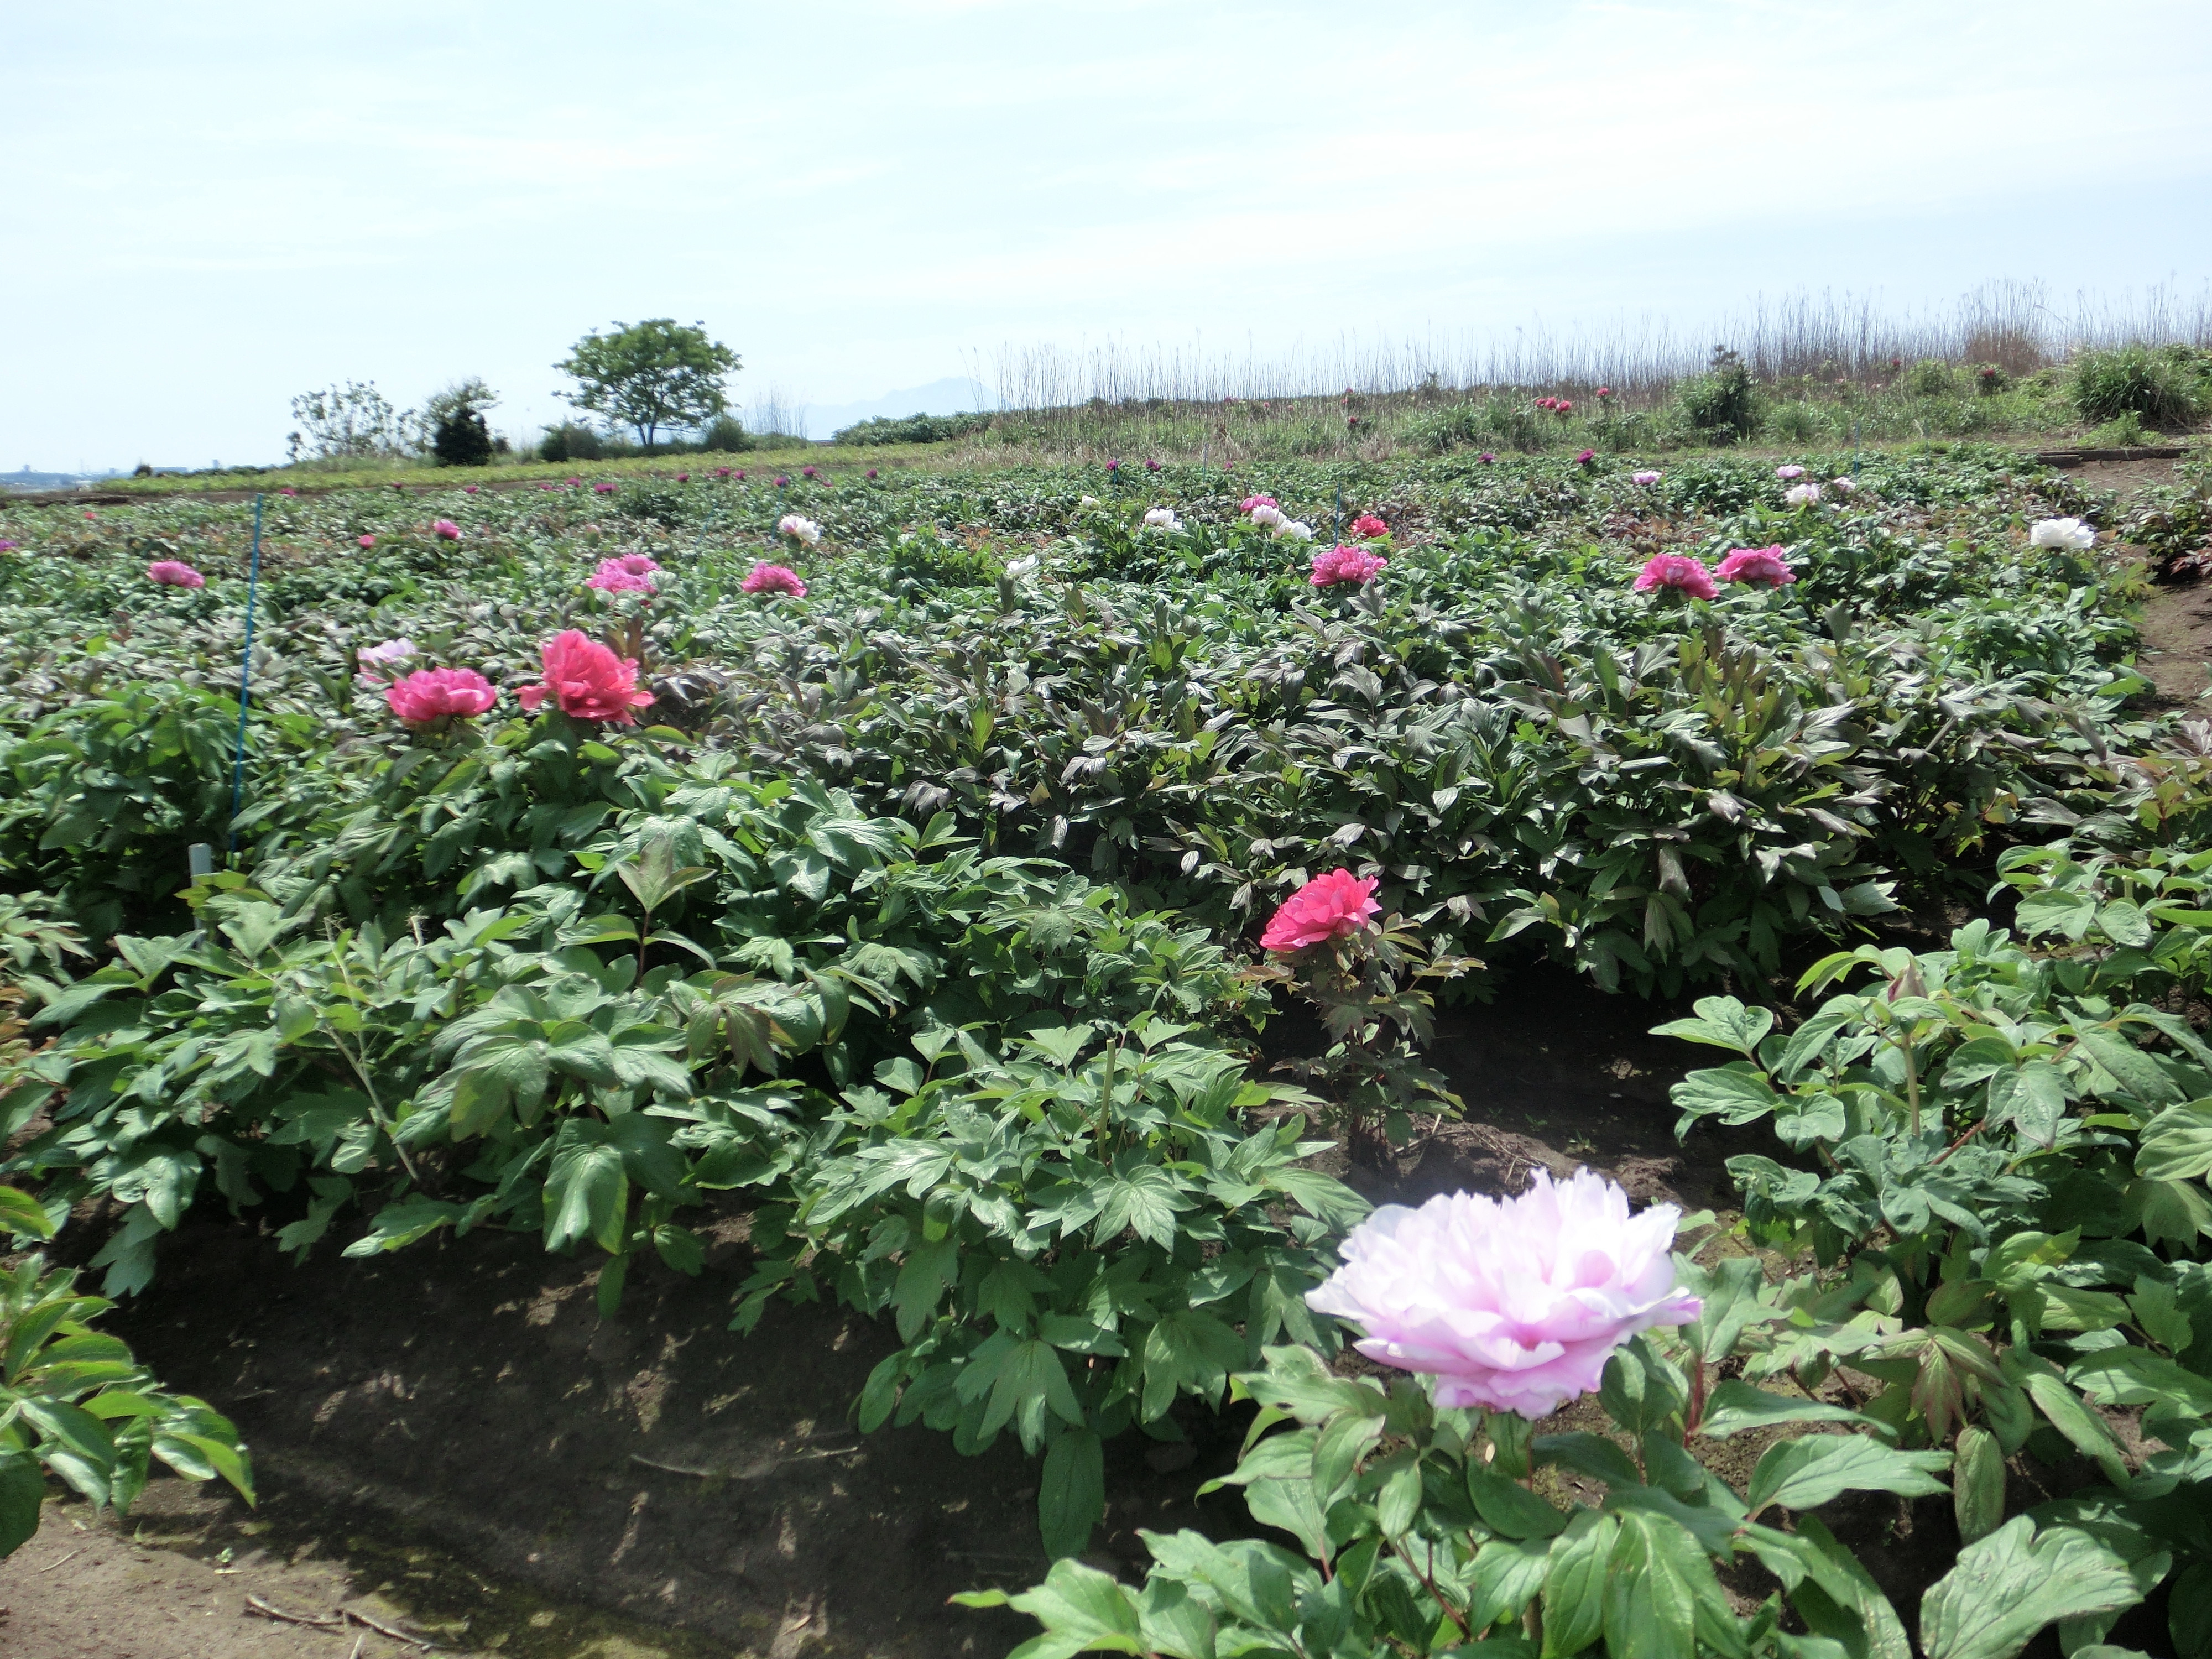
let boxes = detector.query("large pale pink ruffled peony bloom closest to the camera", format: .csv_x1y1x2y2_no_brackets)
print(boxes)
1305,1170,1703,1420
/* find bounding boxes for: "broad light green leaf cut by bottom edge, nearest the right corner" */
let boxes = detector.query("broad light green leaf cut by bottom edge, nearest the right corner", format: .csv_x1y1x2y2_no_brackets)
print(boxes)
1920,1515,2143,1659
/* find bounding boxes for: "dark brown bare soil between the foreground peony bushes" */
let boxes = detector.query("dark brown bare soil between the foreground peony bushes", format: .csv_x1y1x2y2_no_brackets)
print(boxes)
0,969,1741,1659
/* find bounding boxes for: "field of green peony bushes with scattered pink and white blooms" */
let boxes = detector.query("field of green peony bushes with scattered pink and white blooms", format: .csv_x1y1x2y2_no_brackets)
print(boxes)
0,442,2212,1659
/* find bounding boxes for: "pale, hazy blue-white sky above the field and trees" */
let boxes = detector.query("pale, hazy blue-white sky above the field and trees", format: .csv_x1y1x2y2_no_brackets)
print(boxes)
0,0,2212,469
